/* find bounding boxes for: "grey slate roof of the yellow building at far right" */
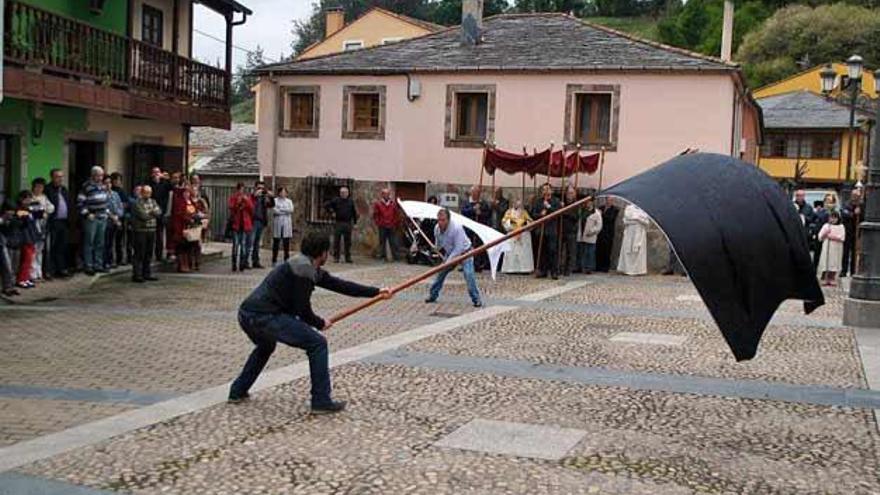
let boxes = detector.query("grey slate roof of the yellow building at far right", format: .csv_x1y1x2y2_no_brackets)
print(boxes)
757,90,870,129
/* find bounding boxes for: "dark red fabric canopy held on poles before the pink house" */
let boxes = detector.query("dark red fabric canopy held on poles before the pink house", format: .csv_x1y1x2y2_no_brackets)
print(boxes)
483,148,599,178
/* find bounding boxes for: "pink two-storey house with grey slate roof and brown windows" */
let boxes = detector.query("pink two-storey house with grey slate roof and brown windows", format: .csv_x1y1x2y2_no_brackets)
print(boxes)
251,2,761,248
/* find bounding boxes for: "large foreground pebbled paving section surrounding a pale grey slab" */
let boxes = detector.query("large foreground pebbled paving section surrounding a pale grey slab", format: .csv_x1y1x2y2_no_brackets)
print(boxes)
21,364,880,494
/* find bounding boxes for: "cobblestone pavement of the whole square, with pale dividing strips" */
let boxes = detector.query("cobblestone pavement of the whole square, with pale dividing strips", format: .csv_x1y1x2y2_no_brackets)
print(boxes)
0,260,880,494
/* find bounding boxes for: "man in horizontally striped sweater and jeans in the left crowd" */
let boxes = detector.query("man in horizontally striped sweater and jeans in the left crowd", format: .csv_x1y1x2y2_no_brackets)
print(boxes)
76,167,110,275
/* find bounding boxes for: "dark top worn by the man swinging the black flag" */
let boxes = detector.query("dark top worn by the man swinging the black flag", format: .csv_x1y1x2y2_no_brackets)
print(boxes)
240,254,379,330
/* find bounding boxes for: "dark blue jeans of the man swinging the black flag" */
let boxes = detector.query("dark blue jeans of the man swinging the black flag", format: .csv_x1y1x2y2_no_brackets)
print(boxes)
229,310,331,406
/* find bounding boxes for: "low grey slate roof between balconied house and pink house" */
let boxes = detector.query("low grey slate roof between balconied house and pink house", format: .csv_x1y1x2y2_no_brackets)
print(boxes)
190,124,260,175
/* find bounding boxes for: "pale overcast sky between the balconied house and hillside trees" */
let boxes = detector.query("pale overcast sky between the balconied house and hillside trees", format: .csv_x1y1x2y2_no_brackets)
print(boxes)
193,0,312,67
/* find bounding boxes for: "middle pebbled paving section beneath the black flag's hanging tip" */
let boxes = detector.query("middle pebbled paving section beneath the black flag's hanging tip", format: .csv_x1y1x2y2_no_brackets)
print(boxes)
407,310,866,388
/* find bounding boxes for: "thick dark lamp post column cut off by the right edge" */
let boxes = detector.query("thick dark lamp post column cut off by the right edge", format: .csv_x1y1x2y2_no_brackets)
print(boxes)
843,69,880,329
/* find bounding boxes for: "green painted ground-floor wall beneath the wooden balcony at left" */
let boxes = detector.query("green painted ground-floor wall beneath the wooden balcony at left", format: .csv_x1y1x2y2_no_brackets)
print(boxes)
0,98,87,193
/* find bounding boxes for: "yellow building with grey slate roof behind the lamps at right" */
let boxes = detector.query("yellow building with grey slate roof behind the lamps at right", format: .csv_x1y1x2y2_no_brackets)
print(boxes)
754,63,877,186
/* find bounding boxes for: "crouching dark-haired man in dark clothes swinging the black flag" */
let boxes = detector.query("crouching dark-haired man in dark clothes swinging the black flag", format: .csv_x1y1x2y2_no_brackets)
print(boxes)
229,232,391,414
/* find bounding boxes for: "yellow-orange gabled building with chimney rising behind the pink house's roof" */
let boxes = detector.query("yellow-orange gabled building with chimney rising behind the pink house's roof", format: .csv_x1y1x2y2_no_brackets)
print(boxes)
297,7,444,59
